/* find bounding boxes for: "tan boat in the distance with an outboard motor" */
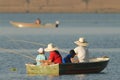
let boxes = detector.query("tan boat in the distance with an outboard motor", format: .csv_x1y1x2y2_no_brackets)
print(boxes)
10,21,59,28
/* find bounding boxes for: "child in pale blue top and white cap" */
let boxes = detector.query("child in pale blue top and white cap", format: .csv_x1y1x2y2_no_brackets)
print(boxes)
36,48,47,65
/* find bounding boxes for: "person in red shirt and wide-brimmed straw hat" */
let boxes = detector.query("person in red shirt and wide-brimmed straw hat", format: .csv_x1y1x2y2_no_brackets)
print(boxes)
45,43,62,64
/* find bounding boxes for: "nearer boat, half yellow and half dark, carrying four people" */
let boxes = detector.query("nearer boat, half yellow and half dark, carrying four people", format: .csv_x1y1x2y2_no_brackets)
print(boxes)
26,57,109,76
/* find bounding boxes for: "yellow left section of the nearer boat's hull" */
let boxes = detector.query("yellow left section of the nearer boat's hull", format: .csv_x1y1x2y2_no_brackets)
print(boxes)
26,64,59,76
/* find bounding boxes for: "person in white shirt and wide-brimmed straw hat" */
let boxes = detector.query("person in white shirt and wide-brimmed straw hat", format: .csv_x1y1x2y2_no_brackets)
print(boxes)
74,37,89,62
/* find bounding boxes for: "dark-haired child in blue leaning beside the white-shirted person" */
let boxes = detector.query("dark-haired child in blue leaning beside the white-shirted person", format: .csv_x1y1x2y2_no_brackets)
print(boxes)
62,49,78,63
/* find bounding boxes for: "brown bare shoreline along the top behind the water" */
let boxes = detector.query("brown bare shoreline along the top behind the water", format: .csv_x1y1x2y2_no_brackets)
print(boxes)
0,0,120,13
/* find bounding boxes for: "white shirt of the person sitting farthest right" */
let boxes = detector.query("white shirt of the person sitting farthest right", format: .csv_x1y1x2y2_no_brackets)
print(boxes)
74,46,89,62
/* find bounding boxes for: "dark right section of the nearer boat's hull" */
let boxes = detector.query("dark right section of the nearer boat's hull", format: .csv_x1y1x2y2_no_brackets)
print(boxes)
59,61,108,75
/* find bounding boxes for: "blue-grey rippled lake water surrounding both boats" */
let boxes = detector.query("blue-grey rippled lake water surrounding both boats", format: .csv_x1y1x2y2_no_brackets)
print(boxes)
0,13,120,80
